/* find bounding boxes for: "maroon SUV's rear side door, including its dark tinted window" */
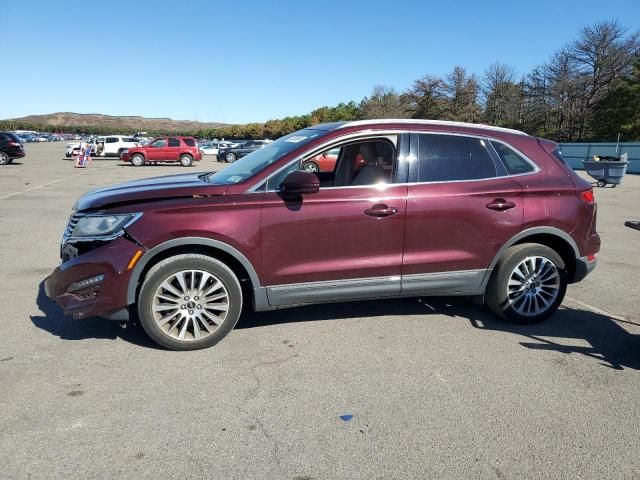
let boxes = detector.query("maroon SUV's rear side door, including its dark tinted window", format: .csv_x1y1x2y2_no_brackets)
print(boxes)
402,133,524,294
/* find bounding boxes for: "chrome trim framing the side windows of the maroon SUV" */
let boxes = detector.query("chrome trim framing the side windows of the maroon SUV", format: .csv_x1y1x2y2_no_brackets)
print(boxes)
245,130,542,193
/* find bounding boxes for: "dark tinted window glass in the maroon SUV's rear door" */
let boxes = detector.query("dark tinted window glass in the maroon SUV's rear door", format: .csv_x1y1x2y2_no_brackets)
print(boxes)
409,134,497,182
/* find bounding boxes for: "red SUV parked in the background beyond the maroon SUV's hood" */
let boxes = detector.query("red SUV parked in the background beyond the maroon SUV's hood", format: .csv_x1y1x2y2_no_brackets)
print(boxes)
121,137,202,167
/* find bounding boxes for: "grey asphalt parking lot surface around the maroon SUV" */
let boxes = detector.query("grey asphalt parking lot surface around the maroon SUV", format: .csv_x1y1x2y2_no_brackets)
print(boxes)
0,143,640,480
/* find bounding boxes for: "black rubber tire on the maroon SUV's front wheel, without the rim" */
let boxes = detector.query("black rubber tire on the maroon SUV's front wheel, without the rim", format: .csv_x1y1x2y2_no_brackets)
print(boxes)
137,254,243,350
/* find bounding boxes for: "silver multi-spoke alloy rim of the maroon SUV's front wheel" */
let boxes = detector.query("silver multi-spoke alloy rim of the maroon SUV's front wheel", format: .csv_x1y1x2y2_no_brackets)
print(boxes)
151,270,229,342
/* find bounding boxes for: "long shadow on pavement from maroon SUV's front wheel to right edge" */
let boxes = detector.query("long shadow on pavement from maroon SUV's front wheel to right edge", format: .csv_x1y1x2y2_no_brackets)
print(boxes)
236,297,640,370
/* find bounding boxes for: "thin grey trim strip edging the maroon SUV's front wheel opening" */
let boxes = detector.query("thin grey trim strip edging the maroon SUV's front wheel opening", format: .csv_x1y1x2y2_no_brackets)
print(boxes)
127,237,260,305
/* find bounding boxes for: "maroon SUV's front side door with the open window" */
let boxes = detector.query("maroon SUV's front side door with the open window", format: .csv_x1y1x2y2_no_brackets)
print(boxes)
261,138,407,305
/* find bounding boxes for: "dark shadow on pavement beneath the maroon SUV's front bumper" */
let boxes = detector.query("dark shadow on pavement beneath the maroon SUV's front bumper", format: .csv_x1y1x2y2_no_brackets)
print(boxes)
31,281,161,350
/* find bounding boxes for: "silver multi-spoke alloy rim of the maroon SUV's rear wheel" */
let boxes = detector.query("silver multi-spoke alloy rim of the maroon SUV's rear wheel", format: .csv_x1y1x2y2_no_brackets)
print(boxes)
507,256,560,316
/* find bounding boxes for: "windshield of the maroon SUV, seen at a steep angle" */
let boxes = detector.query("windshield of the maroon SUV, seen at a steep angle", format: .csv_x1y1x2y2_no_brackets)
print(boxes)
208,128,327,185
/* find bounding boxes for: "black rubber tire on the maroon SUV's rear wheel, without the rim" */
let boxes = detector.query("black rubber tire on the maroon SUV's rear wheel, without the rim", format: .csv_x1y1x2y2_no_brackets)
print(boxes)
487,244,567,324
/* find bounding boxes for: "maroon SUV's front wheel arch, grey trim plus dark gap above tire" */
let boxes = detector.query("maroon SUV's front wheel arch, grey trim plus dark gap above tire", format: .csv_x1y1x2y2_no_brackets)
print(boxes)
127,237,260,305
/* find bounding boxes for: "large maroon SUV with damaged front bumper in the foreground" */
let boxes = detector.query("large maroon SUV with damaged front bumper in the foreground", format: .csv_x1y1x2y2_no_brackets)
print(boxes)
45,120,600,350
